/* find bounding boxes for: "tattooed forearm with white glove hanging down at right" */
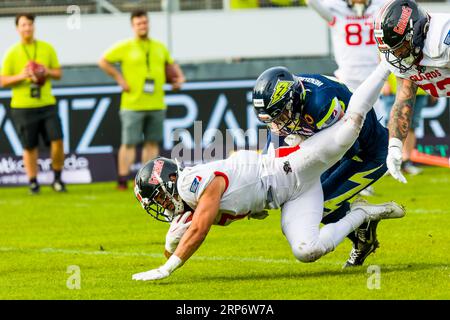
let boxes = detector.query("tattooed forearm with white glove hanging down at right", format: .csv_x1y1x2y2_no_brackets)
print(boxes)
386,77,417,183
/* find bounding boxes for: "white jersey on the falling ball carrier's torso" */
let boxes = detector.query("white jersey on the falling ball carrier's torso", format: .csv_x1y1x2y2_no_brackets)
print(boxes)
177,147,299,226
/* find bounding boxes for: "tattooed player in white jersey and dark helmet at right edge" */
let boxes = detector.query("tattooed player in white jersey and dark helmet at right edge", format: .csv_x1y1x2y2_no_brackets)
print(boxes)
374,0,450,183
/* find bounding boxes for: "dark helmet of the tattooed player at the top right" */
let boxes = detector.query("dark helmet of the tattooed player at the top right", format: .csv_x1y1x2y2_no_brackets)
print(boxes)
374,0,430,73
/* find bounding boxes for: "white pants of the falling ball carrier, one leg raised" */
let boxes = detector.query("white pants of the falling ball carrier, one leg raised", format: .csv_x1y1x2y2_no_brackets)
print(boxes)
274,64,389,262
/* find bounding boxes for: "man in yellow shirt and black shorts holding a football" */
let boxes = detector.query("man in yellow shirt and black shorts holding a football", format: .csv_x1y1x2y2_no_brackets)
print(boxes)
1,14,66,194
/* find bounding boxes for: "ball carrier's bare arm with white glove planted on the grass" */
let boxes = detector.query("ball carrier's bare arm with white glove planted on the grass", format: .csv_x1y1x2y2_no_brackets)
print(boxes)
133,176,226,281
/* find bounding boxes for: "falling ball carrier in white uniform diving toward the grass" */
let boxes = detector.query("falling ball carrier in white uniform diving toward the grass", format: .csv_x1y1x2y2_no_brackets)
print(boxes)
132,64,405,281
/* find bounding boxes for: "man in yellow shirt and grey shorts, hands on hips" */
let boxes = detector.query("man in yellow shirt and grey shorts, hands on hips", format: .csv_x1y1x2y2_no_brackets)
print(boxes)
99,10,185,190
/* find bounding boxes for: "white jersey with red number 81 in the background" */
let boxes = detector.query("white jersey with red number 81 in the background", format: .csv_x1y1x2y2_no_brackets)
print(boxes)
322,0,385,90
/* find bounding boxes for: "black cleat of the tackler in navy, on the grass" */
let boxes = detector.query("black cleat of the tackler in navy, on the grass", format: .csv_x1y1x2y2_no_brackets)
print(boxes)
343,221,380,268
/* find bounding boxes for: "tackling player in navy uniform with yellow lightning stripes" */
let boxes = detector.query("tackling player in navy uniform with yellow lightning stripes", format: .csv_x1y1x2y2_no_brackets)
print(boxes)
253,67,388,267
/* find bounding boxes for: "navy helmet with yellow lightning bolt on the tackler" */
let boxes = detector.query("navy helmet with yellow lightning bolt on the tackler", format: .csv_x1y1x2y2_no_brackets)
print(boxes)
253,67,306,136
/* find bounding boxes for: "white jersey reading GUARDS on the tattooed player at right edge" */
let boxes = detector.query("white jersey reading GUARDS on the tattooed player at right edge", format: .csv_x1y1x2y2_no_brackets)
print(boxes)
383,13,450,97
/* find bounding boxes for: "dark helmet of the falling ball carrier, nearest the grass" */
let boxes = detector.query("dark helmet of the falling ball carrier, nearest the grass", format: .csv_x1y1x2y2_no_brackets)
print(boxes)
134,157,185,222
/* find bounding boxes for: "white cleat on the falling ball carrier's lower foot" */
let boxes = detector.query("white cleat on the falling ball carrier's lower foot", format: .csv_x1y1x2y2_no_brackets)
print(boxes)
350,198,406,221
